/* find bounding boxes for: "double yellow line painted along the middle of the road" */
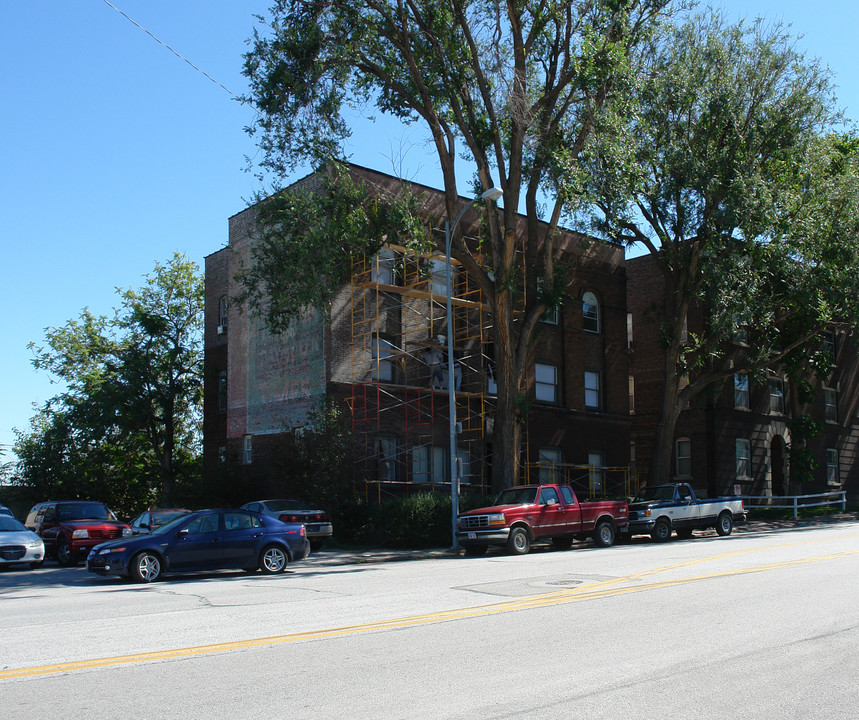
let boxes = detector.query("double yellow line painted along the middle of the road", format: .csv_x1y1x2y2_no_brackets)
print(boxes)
0,540,859,680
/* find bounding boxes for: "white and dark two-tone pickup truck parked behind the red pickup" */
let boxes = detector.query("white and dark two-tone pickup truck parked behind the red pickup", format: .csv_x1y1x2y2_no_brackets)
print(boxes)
628,483,746,542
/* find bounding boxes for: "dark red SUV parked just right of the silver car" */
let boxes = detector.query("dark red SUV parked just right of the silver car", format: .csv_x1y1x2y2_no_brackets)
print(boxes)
24,500,131,565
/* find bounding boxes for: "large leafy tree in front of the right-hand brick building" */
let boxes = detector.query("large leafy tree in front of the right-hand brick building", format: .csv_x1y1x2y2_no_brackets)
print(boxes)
590,13,859,481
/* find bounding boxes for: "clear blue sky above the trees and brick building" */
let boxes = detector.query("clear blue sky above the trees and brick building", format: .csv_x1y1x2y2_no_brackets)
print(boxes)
0,0,859,459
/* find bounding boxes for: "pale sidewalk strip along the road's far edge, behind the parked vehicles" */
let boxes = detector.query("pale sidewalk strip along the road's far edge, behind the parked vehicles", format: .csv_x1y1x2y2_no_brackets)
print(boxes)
302,512,859,567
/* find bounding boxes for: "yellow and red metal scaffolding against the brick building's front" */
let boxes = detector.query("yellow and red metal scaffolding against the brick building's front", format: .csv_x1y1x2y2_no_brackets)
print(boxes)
348,246,493,494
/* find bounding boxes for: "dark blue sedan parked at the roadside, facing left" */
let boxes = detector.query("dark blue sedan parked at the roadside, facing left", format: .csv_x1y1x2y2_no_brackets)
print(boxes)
86,510,310,582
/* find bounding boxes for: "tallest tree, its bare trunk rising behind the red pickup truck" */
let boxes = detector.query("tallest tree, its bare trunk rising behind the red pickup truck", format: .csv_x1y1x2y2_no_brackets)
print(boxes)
240,0,669,487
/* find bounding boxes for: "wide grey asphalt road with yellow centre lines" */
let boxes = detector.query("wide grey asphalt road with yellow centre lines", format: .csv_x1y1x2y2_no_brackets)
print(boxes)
0,520,859,720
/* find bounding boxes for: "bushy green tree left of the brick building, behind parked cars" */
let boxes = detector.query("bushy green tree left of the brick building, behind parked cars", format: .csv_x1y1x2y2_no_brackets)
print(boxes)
15,254,203,509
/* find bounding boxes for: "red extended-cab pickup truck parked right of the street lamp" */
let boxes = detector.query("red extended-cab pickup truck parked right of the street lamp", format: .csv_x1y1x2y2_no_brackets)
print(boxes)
456,485,629,555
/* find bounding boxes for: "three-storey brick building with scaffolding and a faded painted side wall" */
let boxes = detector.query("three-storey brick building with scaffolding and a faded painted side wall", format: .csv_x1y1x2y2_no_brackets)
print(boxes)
204,166,631,495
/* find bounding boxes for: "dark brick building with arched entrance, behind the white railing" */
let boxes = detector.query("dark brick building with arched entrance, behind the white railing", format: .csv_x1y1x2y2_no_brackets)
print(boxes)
627,256,859,496
